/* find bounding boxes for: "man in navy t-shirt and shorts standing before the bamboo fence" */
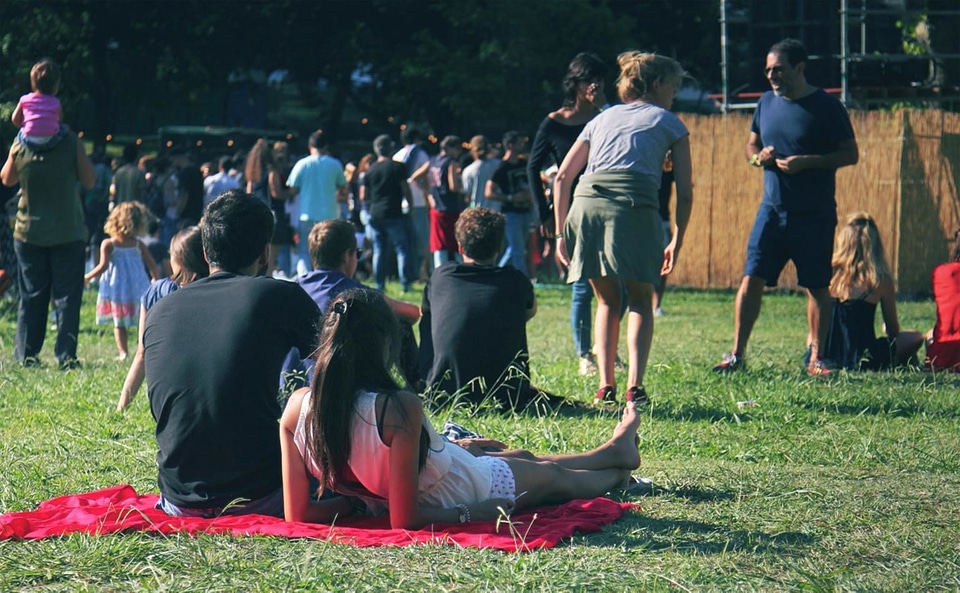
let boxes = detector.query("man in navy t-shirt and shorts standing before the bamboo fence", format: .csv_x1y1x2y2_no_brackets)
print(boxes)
713,39,859,377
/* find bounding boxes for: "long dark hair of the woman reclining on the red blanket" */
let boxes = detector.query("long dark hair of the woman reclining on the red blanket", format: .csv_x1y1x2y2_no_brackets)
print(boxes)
306,288,427,487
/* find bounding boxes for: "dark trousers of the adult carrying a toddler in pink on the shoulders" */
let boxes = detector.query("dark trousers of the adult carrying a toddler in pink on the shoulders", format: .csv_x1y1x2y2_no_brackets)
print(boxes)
13,241,86,364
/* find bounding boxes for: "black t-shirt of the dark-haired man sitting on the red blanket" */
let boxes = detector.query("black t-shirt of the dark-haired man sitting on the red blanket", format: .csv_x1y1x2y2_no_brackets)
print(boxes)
143,272,320,508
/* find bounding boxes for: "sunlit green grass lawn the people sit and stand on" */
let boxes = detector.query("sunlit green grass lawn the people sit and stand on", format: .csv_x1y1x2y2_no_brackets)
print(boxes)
0,286,960,591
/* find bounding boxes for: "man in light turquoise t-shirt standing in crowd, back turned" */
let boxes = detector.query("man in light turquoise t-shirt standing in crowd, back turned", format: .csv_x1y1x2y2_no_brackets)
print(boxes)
287,130,349,273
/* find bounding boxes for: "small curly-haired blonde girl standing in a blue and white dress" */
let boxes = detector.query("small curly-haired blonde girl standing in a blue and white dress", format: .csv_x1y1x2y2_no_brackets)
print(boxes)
83,202,160,360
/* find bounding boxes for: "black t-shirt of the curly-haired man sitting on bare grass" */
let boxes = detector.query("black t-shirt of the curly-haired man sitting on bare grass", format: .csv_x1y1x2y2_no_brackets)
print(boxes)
420,263,534,406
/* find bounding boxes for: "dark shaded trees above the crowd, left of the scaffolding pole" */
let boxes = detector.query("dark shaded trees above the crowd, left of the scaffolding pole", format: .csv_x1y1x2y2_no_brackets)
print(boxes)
0,0,719,140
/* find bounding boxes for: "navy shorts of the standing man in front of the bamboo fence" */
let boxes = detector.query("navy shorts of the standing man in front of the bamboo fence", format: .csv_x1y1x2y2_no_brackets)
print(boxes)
744,204,837,289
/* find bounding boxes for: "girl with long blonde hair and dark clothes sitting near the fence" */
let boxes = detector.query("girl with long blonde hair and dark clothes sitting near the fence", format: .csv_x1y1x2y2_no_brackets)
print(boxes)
825,212,923,370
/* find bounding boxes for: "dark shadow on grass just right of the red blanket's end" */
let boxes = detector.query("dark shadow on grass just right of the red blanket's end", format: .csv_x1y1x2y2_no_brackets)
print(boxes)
625,517,818,556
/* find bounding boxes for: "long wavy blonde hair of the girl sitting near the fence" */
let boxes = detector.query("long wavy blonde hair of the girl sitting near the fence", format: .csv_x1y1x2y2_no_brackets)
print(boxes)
830,212,891,301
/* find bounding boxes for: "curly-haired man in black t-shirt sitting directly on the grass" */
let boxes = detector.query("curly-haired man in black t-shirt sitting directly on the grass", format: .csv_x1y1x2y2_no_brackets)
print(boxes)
420,208,563,410
